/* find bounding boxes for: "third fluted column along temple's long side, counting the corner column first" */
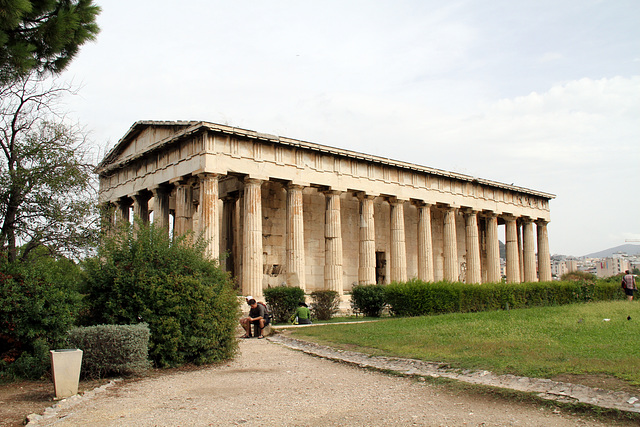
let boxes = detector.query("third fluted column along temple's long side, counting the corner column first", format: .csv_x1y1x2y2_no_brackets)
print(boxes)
287,184,305,290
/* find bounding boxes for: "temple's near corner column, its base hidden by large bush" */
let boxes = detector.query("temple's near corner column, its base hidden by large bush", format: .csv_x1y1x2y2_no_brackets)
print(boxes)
198,173,220,259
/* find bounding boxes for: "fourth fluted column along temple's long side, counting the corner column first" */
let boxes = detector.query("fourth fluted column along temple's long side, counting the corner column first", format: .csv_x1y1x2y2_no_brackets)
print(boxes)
324,191,344,295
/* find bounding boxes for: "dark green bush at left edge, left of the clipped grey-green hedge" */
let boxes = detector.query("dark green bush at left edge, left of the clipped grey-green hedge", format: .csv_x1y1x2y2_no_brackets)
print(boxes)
0,254,81,380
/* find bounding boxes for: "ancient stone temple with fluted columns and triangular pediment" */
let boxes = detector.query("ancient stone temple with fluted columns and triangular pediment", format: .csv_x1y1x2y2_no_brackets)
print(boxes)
98,121,554,296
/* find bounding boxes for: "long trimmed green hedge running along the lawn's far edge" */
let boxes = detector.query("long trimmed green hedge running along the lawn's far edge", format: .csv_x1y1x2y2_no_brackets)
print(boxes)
384,279,624,316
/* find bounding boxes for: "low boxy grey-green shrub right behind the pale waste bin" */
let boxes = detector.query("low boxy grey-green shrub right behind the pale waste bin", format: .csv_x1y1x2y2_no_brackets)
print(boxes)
67,323,150,378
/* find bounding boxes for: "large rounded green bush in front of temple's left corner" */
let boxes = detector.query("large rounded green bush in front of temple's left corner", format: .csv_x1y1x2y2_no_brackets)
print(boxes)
85,223,239,367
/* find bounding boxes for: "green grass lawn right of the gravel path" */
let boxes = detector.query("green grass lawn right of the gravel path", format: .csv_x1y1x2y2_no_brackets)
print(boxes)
291,301,640,386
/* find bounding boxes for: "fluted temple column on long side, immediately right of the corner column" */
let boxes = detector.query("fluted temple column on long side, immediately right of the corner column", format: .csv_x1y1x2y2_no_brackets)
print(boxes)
242,178,264,297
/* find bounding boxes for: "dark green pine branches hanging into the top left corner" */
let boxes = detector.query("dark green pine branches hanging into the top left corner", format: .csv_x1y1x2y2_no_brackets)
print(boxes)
0,0,100,83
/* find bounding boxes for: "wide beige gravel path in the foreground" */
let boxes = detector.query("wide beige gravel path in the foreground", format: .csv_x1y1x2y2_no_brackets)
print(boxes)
29,339,624,426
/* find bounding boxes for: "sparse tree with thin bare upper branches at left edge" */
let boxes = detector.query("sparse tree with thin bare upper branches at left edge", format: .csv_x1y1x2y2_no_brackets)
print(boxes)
0,73,97,262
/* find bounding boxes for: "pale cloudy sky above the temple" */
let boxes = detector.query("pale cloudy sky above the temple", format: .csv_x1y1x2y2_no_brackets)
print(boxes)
57,0,640,256
